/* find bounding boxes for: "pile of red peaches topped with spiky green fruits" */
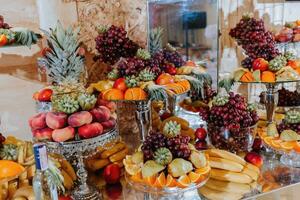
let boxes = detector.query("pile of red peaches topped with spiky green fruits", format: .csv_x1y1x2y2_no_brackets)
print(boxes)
29,87,116,142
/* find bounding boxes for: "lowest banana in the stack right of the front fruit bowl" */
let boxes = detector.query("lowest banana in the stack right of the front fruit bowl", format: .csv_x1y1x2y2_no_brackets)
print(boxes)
205,179,251,194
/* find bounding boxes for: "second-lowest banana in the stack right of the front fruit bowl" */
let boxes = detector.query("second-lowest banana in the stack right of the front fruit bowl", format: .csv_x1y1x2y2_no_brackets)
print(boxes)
210,169,252,183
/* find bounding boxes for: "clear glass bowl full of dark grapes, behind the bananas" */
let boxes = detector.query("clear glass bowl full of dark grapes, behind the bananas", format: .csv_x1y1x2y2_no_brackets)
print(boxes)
207,123,257,153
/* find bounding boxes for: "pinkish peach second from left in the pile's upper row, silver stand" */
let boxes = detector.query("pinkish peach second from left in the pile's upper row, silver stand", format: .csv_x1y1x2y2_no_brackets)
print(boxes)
46,112,68,129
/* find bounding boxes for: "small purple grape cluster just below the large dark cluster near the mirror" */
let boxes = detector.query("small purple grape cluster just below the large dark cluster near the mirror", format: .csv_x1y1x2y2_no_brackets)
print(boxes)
117,57,145,77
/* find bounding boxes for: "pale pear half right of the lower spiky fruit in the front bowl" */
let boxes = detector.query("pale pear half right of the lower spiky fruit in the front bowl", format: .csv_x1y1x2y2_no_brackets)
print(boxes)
168,158,193,177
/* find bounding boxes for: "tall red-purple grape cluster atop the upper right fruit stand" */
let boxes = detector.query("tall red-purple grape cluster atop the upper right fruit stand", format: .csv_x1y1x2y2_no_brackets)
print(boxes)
229,17,280,68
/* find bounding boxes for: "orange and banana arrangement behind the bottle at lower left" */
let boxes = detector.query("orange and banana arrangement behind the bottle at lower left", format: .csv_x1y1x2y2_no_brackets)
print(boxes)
0,136,77,200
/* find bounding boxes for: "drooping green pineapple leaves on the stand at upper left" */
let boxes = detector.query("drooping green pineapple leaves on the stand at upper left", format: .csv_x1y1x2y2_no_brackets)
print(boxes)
12,28,38,47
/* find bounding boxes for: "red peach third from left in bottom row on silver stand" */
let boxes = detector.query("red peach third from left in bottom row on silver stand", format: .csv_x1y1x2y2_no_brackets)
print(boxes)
78,122,103,138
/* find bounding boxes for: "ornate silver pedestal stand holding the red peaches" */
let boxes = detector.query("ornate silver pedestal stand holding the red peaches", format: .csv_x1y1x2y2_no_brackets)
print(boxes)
47,128,119,200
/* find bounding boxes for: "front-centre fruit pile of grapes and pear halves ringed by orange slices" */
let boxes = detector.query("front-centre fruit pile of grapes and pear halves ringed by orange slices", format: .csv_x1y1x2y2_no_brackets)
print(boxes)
123,123,210,189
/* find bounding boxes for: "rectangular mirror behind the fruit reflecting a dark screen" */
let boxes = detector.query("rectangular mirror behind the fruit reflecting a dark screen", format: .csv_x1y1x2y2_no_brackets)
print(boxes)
148,0,218,86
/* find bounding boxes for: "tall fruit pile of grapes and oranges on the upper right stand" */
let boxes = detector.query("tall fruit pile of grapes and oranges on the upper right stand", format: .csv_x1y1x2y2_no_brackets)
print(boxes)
229,15,300,83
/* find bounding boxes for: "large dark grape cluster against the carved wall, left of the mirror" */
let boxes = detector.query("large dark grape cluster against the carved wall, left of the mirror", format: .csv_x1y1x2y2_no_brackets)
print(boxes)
96,25,139,65
